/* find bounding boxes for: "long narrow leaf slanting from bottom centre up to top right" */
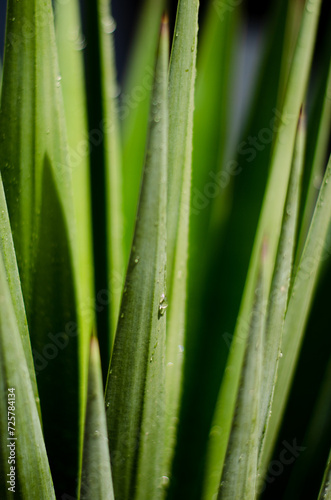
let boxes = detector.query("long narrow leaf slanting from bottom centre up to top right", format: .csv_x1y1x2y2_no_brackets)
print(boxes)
204,1,320,499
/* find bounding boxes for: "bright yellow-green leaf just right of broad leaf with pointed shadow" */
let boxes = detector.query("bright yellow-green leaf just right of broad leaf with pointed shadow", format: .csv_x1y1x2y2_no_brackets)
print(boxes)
55,0,95,464
